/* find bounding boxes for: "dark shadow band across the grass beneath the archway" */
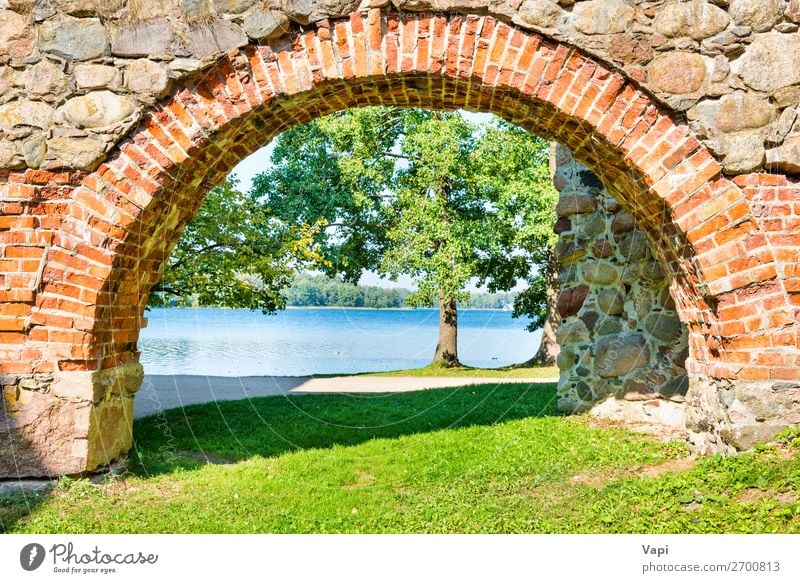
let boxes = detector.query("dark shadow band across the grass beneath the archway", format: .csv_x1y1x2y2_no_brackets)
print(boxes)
130,383,557,476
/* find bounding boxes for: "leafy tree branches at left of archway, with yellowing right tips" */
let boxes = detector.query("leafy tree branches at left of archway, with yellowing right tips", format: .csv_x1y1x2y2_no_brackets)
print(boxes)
150,178,324,312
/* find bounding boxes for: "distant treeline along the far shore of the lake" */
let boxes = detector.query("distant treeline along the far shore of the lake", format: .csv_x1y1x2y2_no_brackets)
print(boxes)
286,274,515,309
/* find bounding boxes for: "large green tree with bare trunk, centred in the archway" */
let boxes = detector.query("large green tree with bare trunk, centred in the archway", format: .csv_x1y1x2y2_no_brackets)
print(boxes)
253,108,554,366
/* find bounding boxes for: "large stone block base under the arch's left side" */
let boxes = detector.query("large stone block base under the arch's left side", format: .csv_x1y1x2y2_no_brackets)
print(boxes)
0,363,143,478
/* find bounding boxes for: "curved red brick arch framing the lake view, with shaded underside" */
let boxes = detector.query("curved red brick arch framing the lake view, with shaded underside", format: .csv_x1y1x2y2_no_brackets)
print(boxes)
3,10,800,476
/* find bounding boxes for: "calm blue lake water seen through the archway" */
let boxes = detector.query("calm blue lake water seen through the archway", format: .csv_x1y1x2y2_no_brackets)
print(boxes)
139,308,541,376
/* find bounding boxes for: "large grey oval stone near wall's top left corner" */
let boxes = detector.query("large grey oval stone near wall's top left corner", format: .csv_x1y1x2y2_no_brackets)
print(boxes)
39,17,108,61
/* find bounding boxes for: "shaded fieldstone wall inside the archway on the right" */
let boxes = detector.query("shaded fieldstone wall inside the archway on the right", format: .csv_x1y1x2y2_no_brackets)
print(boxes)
554,145,689,428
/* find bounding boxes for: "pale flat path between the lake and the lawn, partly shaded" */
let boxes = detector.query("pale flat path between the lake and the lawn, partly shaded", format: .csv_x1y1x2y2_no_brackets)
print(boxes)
134,375,558,417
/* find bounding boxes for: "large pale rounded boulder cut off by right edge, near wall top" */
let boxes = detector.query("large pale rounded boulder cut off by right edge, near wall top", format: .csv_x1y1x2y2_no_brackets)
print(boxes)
732,32,800,92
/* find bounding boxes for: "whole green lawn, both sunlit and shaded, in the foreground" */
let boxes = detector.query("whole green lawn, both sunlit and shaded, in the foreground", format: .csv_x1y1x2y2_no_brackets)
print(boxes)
0,384,800,533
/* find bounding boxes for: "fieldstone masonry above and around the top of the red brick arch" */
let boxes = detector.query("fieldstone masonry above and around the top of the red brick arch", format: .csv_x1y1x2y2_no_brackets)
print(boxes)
0,0,800,174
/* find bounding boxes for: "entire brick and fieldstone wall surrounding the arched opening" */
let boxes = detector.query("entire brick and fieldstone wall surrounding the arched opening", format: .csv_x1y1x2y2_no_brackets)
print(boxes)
0,5,800,475
